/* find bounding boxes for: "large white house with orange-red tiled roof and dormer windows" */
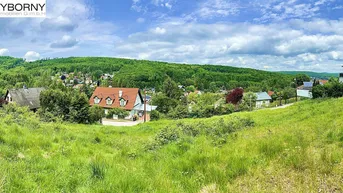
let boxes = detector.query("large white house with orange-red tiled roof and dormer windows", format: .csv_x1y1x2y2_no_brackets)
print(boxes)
89,87,157,119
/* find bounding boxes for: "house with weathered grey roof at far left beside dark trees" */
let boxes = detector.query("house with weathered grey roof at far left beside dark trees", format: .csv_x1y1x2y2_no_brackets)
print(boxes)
5,88,44,111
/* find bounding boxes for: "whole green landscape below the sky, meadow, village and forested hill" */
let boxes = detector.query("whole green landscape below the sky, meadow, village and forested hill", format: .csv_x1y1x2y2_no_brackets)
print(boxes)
0,57,343,192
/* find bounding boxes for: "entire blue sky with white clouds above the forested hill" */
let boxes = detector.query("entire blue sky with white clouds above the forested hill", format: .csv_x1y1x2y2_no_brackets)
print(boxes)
0,0,343,72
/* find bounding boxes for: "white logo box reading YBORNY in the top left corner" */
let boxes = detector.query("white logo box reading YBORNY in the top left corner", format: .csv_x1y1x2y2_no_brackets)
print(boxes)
0,0,46,17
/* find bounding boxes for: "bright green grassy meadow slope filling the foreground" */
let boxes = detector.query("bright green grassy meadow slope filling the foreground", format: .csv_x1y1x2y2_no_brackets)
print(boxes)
0,99,343,192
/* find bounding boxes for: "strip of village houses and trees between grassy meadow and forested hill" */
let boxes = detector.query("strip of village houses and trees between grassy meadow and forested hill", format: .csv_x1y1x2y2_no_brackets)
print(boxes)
1,61,342,123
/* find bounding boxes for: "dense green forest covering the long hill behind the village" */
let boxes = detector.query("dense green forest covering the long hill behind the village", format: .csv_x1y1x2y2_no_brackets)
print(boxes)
0,57,293,93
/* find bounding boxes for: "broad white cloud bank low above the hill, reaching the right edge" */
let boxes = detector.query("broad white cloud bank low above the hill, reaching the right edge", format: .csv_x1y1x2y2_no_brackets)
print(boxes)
114,21,343,71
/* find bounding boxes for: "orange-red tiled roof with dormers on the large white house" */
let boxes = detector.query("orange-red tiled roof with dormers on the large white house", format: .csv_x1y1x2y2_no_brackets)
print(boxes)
89,87,140,110
